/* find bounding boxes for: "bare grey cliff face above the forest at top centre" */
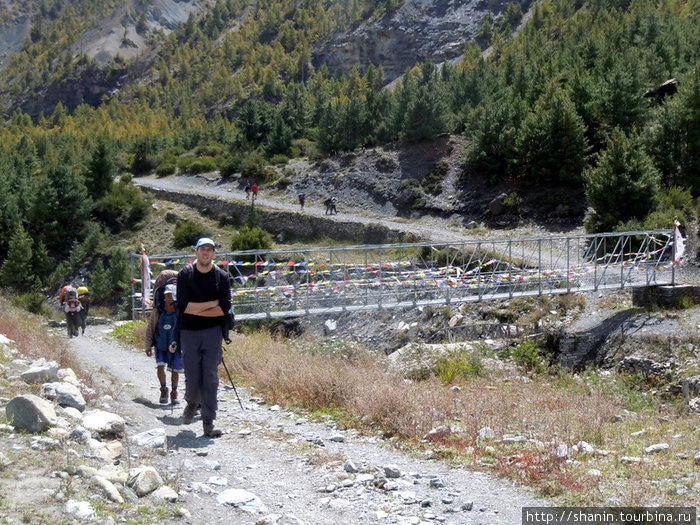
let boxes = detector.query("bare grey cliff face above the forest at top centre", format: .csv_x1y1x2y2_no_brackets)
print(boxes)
313,0,509,81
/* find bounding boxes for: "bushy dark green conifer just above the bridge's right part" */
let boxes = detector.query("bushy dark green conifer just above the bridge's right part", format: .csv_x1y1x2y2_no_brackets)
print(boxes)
584,128,660,232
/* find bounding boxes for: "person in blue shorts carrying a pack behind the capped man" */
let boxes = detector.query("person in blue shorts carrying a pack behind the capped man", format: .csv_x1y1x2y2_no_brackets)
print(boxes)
144,270,184,405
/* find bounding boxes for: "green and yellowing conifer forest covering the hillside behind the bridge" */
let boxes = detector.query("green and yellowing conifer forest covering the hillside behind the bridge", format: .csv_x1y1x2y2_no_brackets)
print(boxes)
0,0,700,310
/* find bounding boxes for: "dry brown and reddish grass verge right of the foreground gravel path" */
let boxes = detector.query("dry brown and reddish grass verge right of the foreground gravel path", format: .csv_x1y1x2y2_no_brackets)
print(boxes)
226,333,700,505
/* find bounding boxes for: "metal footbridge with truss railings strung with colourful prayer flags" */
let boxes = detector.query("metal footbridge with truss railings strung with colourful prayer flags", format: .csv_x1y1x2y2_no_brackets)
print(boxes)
132,230,676,320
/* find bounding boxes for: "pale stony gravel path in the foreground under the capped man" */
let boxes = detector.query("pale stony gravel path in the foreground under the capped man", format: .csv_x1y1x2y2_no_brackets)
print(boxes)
70,326,547,525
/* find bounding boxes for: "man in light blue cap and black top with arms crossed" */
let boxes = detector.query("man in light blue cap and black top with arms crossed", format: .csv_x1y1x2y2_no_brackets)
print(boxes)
177,237,231,437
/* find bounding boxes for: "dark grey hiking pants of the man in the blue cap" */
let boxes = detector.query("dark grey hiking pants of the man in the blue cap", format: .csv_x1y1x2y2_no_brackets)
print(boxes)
180,326,223,420
